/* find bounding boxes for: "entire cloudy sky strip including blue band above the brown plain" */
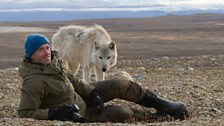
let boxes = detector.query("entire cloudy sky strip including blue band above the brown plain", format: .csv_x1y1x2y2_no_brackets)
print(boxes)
0,0,224,21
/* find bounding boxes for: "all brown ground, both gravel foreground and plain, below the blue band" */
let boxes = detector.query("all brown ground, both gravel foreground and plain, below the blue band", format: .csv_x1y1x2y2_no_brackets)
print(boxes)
0,14,224,126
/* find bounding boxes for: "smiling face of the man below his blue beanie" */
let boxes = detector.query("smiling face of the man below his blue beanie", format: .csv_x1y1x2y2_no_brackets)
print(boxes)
31,44,51,65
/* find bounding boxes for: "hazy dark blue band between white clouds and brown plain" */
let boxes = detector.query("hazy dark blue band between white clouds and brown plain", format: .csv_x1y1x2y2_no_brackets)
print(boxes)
0,10,224,22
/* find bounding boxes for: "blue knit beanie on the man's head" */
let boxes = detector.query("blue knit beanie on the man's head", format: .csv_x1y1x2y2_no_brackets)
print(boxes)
24,34,49,58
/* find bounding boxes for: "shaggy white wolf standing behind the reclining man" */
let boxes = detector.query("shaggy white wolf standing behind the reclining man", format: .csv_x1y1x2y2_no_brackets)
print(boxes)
52,25,117,83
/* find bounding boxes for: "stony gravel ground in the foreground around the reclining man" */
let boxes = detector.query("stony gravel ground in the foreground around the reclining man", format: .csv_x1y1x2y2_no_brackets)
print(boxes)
0,55,224,126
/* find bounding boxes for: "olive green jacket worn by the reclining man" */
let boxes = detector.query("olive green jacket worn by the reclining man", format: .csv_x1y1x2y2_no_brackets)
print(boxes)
18,52,93,119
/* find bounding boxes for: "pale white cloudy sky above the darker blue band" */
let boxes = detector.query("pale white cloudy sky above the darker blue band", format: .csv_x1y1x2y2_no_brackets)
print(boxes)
0,0,224,11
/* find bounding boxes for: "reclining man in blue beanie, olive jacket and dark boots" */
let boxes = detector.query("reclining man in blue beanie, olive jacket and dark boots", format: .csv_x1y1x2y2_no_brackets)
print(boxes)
18,34,188,122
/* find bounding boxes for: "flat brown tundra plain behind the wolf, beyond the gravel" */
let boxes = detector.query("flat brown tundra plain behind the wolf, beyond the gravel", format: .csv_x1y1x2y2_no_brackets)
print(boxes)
0,14,224,68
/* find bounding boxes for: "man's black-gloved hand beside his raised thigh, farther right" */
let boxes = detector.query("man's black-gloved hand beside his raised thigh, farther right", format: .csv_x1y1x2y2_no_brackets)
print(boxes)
87,89,104,114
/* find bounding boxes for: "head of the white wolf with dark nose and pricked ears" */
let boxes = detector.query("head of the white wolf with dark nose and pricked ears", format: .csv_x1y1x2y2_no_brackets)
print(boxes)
92,42,117,72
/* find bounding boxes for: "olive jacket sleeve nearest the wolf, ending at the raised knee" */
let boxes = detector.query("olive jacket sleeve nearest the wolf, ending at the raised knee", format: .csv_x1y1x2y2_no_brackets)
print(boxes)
68,72,95,99
